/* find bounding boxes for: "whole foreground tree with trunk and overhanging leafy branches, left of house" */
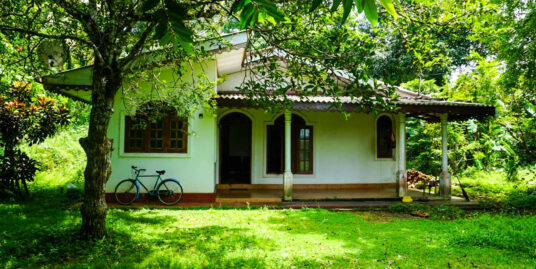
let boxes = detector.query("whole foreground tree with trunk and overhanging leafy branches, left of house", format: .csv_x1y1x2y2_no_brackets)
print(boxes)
0,0,397,238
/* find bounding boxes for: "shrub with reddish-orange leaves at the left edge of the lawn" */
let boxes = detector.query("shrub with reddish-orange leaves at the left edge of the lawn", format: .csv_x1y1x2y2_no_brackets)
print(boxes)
0,83,69,198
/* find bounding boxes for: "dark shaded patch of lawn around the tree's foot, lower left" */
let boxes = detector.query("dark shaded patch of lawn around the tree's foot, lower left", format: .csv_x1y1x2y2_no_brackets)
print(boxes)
0,189,142,268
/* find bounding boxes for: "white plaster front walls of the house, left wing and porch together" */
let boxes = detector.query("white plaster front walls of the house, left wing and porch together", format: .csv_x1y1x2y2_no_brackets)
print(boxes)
106,59,396,193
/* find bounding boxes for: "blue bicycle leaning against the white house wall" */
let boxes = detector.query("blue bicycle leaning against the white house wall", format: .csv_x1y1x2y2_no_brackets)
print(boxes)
114,166,183,205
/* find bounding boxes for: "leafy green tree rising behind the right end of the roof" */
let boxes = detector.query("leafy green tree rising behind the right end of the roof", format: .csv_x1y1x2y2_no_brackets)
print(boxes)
368,0,497,85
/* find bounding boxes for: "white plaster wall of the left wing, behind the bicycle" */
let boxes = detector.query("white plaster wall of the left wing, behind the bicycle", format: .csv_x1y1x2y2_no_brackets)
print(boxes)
106,61,217,193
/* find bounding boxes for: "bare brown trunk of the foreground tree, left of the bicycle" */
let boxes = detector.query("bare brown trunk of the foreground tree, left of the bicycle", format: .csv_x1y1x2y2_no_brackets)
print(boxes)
80,60,121,239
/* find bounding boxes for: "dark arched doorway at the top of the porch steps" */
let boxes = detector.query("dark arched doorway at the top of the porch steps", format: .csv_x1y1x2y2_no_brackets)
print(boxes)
219,112,251,184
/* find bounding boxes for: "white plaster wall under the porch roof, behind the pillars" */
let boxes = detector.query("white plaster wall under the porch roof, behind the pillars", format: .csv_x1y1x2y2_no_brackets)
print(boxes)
218,109,396,184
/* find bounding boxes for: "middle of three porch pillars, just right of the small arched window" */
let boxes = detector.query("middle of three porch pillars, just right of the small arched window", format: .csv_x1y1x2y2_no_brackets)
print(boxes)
396,113,408,197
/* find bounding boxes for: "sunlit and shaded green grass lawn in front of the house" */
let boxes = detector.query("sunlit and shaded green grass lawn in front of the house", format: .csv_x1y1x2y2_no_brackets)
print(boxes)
0,194,536,268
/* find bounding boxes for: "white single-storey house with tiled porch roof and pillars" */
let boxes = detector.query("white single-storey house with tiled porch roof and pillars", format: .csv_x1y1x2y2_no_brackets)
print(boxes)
42,33,495,202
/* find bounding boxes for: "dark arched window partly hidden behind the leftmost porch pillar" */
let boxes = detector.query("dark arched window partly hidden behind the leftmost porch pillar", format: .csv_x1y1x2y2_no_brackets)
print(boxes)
266,114,313,174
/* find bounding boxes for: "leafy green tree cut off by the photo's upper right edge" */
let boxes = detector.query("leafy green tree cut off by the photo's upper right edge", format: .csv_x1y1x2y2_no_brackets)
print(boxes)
494,0,536,163
